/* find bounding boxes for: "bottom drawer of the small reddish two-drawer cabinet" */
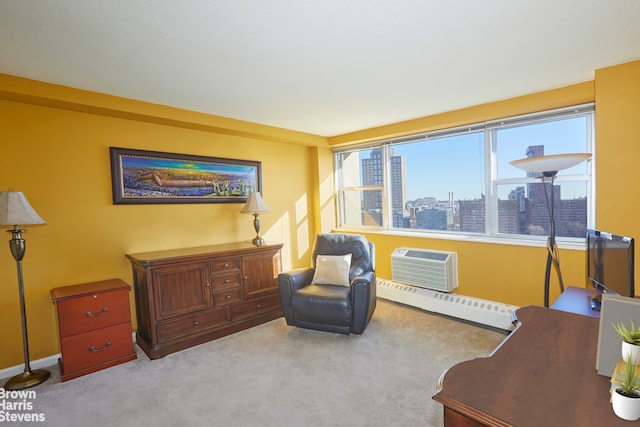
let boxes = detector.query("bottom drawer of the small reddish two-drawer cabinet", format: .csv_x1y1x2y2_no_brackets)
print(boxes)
61,323,134,373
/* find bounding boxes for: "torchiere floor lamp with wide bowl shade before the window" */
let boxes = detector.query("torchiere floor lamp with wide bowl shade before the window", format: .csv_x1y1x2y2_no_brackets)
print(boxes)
509,153,591,307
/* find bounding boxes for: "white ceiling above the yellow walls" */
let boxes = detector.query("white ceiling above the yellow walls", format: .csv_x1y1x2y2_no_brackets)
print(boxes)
0,0,640,136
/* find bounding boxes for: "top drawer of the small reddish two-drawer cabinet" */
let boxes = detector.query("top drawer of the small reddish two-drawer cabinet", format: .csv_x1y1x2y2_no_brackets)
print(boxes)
57,288,131,337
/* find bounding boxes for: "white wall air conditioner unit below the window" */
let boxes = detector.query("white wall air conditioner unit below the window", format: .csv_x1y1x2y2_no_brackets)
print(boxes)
391,248,458,292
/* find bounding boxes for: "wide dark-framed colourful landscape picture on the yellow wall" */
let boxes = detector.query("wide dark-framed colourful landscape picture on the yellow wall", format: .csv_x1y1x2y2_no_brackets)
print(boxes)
109,147,262,204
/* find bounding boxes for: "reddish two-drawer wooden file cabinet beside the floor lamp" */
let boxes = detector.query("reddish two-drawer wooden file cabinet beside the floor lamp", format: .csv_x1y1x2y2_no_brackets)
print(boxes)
51,279,137,381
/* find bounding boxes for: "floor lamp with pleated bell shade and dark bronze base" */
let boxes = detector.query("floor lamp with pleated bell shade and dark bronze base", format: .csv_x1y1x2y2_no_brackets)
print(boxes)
0,191,51,390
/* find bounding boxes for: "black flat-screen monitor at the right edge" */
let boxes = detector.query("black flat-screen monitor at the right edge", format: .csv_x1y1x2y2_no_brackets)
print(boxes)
587,229,635,310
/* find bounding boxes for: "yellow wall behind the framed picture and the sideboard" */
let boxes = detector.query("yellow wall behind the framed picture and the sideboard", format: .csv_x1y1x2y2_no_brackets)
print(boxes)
0,75,328,368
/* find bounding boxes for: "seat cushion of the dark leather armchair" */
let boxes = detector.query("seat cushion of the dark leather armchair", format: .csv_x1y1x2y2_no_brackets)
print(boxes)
291,284,352,326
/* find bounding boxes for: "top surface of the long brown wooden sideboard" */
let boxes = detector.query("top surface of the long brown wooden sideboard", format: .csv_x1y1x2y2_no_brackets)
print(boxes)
127,242,283,264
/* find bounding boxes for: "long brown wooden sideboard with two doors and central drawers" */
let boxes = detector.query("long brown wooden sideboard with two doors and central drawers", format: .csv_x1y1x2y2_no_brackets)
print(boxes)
127,242,283,359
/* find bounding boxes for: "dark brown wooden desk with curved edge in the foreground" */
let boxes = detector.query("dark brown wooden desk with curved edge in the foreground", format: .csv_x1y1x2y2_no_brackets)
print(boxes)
433,306,629,427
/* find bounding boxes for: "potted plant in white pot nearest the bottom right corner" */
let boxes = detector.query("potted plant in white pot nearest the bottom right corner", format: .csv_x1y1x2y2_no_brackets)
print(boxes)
611,356,640,421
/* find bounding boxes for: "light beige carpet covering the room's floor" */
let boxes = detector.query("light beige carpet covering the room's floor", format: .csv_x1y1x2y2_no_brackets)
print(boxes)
3,299,506,427
